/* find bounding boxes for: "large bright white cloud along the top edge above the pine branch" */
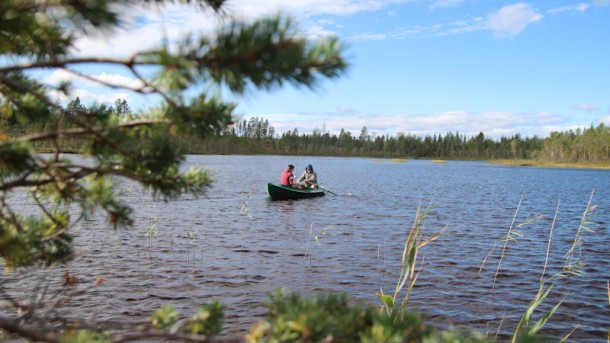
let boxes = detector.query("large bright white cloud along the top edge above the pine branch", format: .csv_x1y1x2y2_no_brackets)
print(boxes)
71,0,414,58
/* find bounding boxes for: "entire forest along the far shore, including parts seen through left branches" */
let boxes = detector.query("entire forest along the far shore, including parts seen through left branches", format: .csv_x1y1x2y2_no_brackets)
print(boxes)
0,98,610,164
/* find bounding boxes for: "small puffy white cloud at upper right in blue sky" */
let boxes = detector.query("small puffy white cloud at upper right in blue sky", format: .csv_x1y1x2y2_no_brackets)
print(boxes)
486,2,543,38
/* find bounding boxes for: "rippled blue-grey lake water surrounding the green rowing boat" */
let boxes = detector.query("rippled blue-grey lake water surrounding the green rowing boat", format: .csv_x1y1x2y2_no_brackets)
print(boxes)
2,156,610,342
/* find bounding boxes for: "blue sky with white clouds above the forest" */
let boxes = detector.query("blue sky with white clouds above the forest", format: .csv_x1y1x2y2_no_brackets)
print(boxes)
45,0,610,138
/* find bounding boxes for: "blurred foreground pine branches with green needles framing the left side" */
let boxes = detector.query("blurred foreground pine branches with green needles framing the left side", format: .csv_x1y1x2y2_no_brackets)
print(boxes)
0,0,347,342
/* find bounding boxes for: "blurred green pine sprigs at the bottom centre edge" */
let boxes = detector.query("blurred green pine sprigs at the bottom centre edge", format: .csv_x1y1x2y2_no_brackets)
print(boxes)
247,290,435,342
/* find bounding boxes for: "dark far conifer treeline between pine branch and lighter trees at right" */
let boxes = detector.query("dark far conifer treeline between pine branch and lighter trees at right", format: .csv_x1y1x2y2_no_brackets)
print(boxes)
189,118,543,160
